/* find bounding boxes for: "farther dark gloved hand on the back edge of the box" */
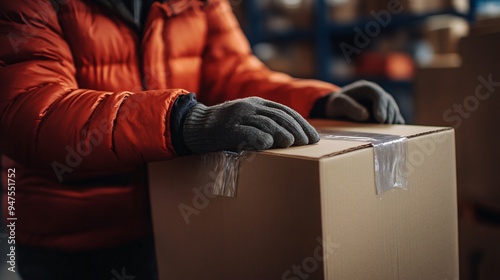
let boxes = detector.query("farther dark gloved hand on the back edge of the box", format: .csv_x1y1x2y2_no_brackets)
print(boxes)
325,80,405,124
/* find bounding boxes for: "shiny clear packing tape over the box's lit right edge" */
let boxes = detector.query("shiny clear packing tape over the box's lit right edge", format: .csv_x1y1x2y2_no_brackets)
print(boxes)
318,130,408,195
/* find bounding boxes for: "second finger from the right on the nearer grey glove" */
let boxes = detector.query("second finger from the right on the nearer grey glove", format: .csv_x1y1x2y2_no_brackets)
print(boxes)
257,107,309,146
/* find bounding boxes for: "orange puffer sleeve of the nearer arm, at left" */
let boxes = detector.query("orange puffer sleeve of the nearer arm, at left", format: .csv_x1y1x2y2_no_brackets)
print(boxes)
0,1,188,179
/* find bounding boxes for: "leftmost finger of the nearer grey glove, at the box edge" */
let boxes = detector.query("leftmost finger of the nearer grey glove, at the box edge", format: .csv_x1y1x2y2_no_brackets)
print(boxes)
230,125,274,150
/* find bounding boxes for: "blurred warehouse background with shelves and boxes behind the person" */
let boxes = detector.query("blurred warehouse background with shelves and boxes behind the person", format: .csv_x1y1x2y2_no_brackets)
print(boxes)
231,0,500,280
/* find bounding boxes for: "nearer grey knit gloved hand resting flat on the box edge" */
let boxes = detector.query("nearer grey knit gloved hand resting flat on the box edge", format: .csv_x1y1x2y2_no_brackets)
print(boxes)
183,97,319,153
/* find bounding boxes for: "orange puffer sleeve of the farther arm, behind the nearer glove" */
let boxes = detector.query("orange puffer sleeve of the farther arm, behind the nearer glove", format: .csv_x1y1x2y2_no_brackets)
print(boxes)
198,0,338,117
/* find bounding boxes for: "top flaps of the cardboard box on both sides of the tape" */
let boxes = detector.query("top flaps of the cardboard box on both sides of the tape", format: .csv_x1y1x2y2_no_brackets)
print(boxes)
261,120,451,159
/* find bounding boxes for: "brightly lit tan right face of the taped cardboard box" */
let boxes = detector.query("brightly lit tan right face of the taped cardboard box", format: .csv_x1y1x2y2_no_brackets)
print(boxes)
321,131,458,280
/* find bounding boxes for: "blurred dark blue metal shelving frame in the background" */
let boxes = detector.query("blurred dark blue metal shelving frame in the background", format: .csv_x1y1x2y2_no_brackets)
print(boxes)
244,0,481,122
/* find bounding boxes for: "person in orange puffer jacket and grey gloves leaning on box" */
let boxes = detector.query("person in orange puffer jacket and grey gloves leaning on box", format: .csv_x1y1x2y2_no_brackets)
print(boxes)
0,0,404,280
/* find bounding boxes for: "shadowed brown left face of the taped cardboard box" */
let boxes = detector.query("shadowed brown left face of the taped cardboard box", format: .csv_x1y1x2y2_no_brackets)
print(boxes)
150,155,322,280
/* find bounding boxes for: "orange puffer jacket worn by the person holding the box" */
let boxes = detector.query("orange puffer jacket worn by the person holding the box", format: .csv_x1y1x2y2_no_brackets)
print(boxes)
0,0,337,251
